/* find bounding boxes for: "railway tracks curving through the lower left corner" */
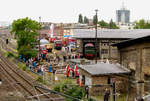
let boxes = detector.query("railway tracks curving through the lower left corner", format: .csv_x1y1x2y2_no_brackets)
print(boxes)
0,54,64,101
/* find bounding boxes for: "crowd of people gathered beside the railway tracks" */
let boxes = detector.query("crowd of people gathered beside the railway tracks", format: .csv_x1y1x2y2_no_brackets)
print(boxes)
19,53,82,77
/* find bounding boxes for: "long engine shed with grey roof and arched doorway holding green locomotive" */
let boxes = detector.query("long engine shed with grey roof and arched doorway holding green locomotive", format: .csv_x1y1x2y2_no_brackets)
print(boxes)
73,29,150,59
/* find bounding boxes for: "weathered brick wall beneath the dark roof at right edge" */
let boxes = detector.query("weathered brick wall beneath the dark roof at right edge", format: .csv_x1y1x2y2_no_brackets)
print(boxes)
119,42,150,96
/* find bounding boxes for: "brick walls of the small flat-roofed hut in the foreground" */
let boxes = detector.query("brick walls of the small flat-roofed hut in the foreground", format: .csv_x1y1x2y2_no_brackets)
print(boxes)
80,69,128,96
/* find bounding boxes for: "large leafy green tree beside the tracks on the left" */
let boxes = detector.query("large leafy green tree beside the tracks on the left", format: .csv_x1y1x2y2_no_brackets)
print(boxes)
11,17,41,58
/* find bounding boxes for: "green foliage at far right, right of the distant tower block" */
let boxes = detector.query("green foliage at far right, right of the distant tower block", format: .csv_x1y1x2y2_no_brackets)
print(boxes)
134,19,150,29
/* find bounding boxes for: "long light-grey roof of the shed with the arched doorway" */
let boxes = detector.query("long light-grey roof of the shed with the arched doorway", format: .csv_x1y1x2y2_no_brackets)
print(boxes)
73,29,150,39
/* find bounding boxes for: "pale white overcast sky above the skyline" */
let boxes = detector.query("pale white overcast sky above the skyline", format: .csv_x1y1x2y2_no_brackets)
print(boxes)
0,0,150,22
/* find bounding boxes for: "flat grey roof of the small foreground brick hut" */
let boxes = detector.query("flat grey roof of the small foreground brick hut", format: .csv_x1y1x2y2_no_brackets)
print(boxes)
79,63,130,76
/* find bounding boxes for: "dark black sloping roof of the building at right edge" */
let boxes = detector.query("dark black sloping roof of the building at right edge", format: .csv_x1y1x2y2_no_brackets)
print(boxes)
112,35,150,48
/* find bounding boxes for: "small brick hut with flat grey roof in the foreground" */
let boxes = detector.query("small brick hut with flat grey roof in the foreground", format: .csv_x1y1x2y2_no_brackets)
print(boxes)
79,63,130,95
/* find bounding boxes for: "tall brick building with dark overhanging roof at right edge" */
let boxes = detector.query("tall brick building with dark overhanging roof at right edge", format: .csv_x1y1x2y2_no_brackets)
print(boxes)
114,35,150,100
